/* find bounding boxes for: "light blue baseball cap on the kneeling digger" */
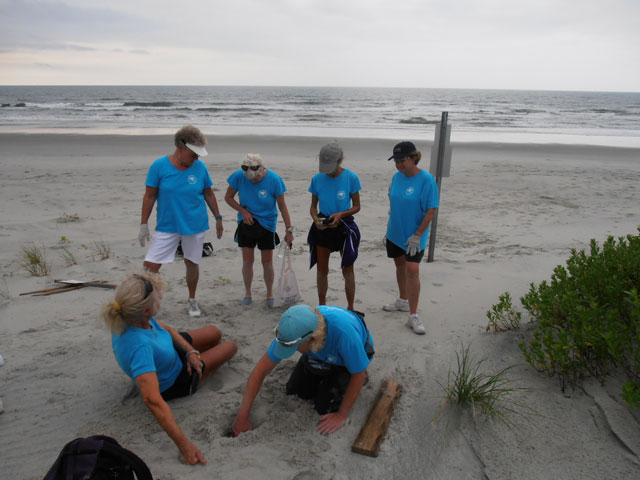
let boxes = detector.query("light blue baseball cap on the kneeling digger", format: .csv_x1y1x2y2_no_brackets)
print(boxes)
273,305,318,359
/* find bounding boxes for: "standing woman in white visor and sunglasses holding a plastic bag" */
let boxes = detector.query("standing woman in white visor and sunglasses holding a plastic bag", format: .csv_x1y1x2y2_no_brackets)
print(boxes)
224,153,293,307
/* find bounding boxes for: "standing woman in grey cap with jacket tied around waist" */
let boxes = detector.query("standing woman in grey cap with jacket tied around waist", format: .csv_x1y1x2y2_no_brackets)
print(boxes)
307,142,361,311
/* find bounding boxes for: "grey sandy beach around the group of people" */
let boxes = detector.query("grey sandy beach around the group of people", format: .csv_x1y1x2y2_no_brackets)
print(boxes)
0,129,640,480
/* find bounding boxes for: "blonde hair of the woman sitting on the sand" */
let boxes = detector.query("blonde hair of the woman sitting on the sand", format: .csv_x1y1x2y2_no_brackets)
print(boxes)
102,271,167,333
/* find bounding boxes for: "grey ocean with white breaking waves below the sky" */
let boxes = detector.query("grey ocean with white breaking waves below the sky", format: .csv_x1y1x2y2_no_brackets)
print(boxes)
0,86,640,147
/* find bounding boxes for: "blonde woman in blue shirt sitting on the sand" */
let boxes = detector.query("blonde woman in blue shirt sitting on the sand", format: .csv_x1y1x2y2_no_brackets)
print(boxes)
102,272,237,465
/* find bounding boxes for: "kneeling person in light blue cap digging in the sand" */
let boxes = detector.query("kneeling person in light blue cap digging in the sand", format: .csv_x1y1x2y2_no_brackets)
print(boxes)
233,305,374,435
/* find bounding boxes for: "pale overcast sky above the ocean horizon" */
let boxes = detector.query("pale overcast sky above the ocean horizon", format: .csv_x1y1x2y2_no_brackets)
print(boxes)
0,0,640,92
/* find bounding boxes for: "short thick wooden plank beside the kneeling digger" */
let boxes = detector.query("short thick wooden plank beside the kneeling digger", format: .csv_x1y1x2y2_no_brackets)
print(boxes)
351,378,402,457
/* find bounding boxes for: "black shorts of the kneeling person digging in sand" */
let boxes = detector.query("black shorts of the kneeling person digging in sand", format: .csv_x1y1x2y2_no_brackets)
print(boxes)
286,354,351,415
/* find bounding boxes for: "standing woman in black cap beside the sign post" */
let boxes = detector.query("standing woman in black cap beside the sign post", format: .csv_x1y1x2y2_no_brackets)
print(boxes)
382,142,439,335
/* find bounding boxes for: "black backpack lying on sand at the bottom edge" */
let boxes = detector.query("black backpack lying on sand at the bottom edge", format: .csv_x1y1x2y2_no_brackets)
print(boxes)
44,435,153,480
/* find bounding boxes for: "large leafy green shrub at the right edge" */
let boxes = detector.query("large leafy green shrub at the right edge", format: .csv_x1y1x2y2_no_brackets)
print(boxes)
520,235,640,407
